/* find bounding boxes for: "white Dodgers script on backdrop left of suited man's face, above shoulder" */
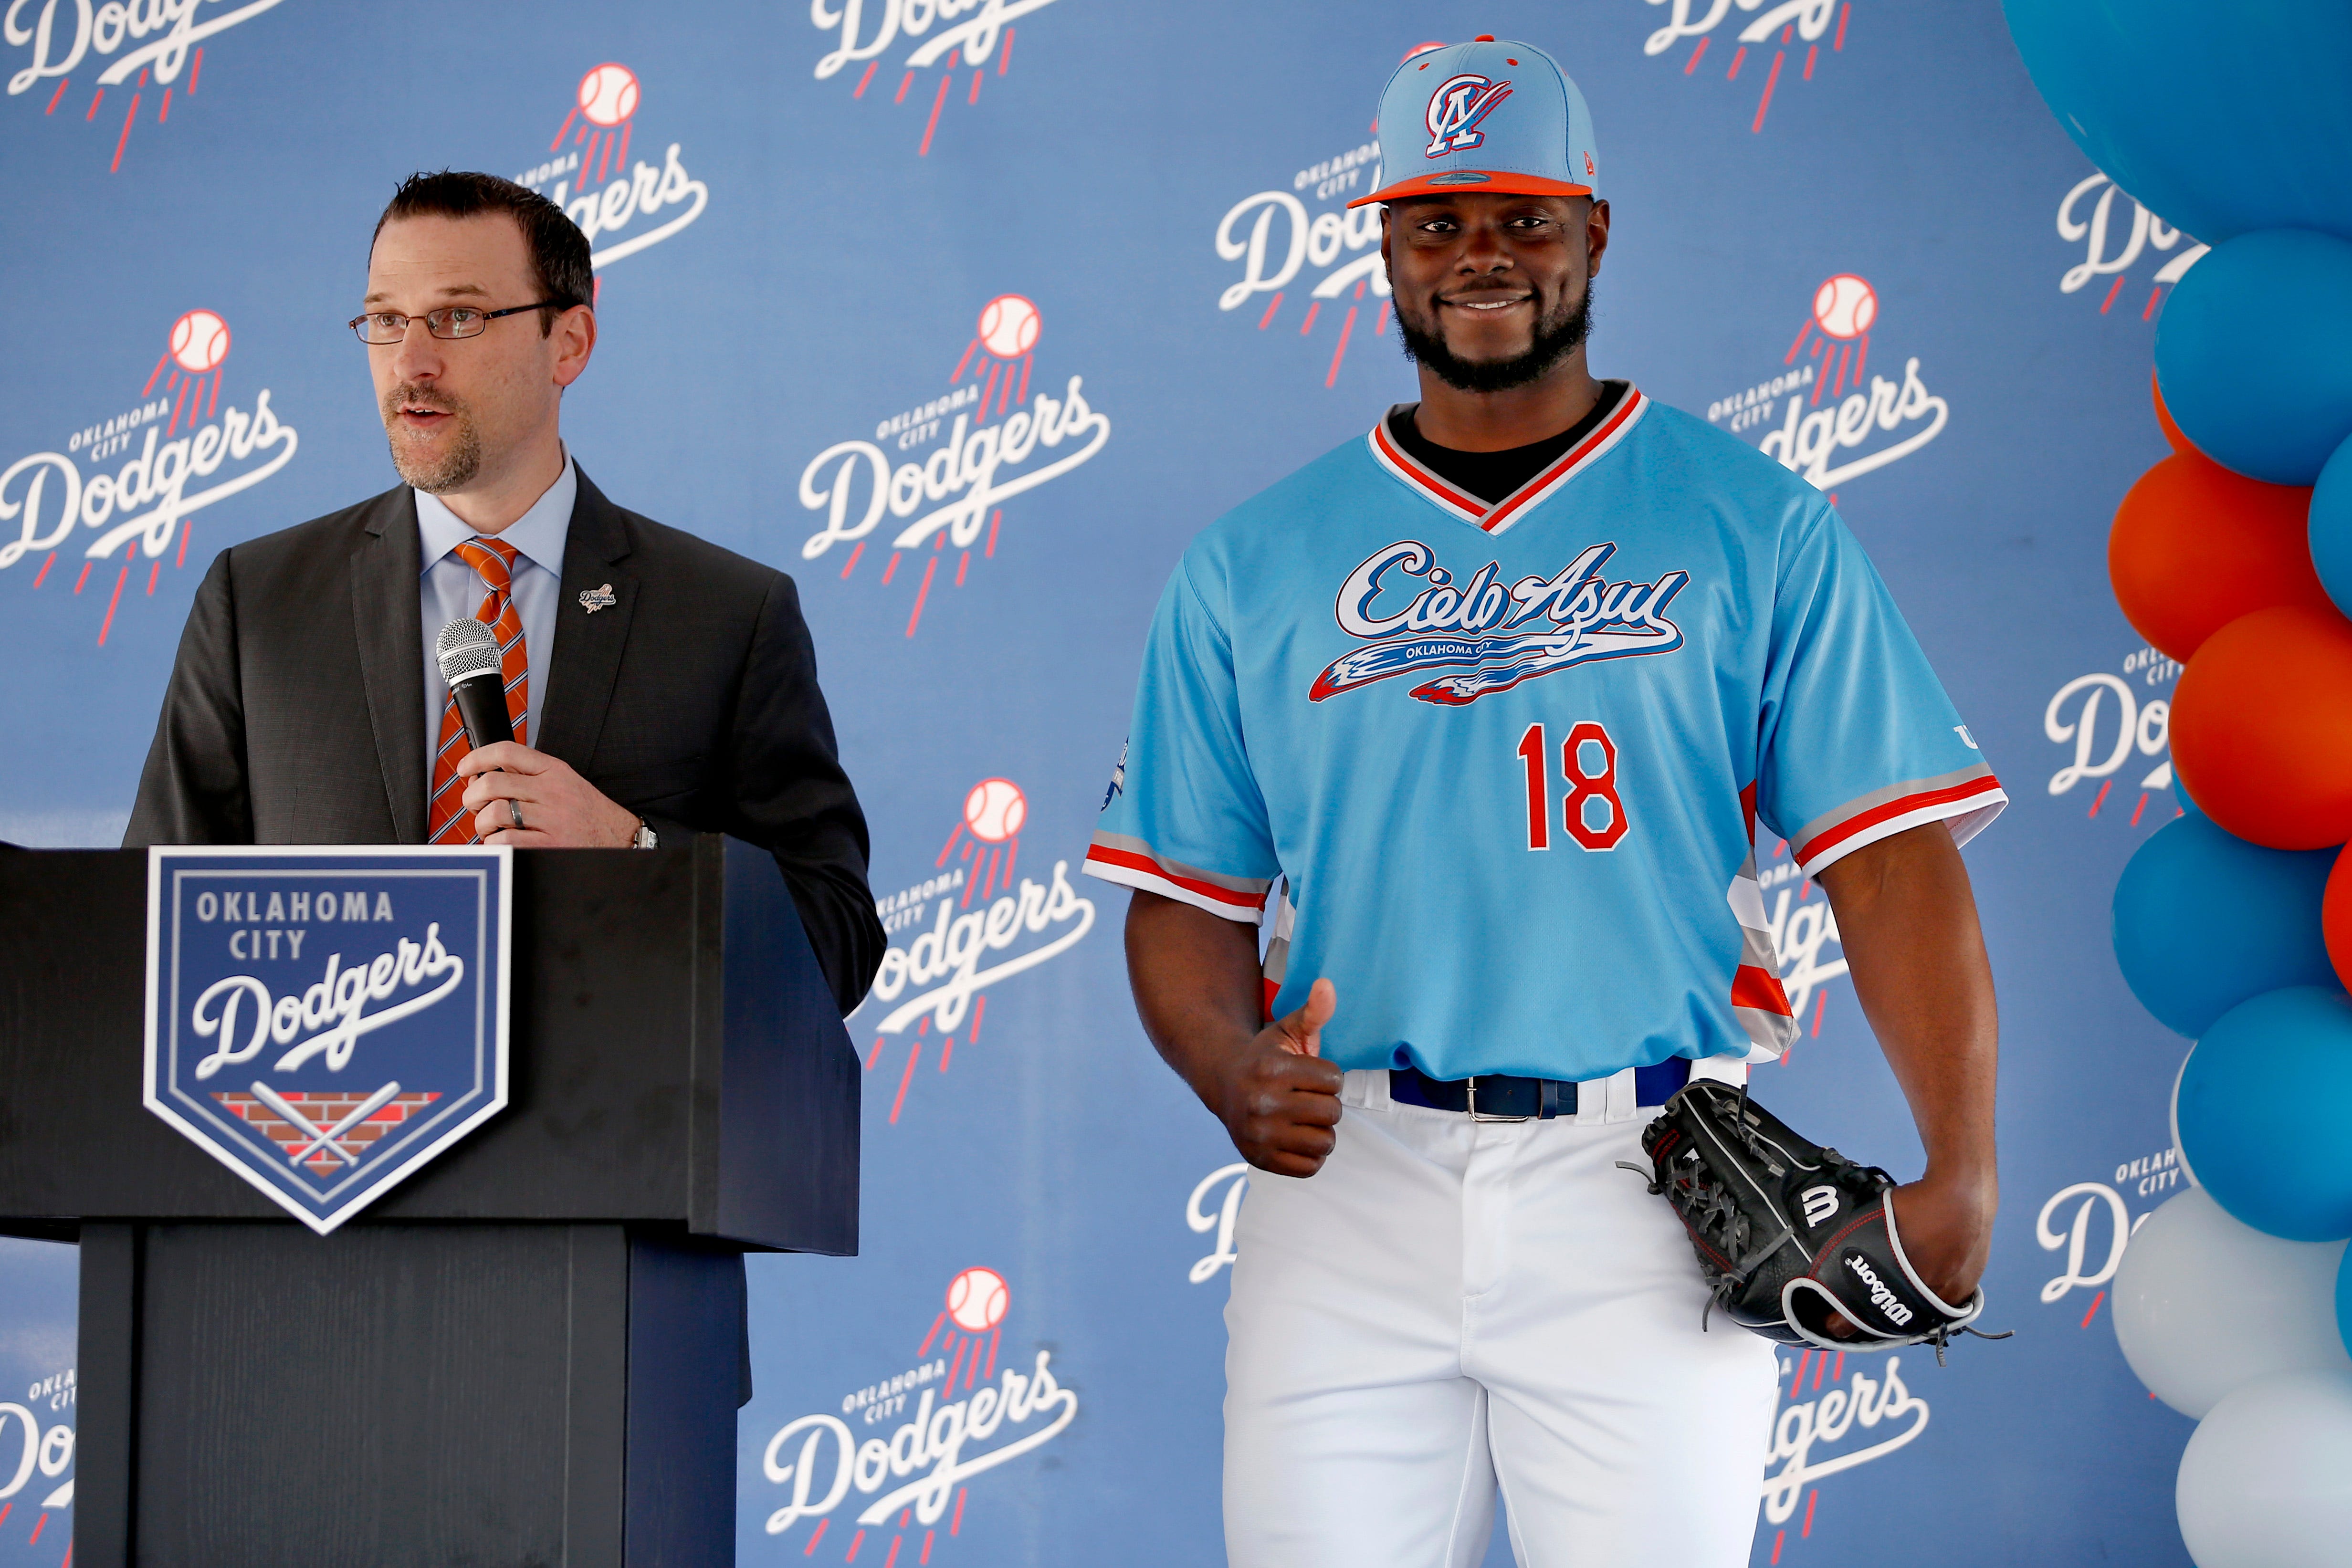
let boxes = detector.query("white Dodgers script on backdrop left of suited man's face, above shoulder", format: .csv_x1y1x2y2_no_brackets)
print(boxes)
0,388,299,571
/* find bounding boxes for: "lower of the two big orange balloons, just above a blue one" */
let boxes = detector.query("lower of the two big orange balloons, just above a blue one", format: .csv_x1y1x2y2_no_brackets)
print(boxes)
2171,604,2352,848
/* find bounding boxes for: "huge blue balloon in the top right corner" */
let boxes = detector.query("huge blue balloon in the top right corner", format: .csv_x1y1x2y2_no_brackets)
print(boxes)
2002,0,2352,242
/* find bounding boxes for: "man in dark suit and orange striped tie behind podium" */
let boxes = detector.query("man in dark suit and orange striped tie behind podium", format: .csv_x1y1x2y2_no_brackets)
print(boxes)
122,172,884,1013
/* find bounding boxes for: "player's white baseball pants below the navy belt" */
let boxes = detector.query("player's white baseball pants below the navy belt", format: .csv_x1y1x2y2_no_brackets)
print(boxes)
1225,1072,1778,1568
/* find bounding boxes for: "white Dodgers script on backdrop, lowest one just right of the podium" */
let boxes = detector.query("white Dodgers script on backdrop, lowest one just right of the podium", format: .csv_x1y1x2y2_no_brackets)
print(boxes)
760,1349,1077,1535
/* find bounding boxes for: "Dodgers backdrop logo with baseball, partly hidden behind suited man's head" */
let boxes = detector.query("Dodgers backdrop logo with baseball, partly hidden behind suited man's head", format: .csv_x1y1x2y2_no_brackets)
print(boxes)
515,61,710,282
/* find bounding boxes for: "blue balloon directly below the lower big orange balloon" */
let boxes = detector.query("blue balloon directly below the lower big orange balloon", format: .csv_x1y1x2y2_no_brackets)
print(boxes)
2114,814,2336,1039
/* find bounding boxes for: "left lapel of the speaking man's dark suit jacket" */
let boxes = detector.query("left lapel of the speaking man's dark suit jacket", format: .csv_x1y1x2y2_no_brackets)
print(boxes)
350,484,426,844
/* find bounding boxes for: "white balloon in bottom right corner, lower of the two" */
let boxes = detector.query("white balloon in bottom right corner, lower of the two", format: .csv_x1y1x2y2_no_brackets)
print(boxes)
2173,1373,2352,1568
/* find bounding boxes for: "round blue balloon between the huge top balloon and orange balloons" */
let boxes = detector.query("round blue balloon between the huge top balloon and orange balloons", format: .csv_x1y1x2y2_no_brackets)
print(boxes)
2157,231,2352,484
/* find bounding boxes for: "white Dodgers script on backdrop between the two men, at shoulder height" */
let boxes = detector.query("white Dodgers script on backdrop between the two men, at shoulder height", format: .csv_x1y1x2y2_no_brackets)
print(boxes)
800,376,1110,562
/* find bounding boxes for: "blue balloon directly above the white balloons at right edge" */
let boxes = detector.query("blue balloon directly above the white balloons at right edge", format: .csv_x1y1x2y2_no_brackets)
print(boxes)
2173,985,2352,1241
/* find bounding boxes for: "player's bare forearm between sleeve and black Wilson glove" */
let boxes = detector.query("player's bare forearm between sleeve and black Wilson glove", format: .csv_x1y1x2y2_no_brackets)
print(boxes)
1820,823,1999,1203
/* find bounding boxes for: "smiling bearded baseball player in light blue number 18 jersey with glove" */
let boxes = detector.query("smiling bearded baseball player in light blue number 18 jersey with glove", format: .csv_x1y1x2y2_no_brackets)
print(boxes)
1087,38,2006,1568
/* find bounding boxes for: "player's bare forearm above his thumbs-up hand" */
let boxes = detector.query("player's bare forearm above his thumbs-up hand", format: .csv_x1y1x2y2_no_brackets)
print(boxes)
1127,889,1265,1112
